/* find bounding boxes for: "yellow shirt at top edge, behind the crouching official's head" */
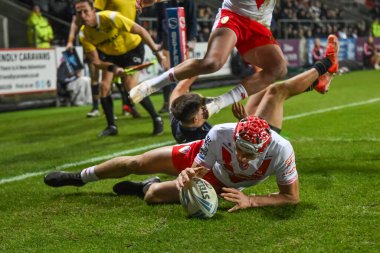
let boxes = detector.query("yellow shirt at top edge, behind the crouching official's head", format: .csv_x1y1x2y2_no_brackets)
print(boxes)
94,0,136,21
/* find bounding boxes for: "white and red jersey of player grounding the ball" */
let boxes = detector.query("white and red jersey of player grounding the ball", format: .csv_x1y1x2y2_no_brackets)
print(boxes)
194,123,298,188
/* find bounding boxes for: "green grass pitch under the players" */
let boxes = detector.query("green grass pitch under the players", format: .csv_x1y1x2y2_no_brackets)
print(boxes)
0,71,380,252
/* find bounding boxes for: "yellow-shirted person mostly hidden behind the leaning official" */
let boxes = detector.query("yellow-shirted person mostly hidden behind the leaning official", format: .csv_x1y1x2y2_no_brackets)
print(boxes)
66,0,139,117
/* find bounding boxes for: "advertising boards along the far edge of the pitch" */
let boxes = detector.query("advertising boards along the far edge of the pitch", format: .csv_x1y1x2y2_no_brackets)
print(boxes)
0,38,380,112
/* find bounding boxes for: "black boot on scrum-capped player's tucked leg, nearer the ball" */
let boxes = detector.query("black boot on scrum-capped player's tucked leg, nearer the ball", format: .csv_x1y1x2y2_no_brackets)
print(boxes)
113,177,161,197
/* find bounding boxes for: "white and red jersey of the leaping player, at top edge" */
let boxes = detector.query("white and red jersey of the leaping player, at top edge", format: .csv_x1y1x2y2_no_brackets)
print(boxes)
222,0,277,28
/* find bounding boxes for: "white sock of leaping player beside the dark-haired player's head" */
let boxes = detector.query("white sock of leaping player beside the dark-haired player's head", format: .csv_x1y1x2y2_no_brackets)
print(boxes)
206,84,248,116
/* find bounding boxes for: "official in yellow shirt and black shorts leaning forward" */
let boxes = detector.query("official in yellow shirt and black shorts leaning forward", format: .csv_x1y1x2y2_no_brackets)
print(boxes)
75,0,166,136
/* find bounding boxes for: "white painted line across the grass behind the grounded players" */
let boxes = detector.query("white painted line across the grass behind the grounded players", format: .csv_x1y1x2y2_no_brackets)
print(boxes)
0,98,380,185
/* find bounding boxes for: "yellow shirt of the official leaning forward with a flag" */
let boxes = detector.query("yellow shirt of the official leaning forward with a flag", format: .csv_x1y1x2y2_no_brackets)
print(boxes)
79,11,142,55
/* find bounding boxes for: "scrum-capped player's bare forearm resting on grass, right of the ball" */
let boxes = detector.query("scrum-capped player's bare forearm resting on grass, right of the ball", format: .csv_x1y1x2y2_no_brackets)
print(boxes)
221,179,299,212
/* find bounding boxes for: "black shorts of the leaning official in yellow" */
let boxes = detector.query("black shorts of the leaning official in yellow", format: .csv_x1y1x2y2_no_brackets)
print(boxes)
98,43,145,68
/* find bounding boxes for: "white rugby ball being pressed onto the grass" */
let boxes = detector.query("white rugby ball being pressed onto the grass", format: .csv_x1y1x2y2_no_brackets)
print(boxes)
179,177,218,219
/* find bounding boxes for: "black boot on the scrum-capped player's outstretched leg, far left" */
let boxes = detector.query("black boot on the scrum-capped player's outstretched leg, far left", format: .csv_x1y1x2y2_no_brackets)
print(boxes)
44,171,86,187
